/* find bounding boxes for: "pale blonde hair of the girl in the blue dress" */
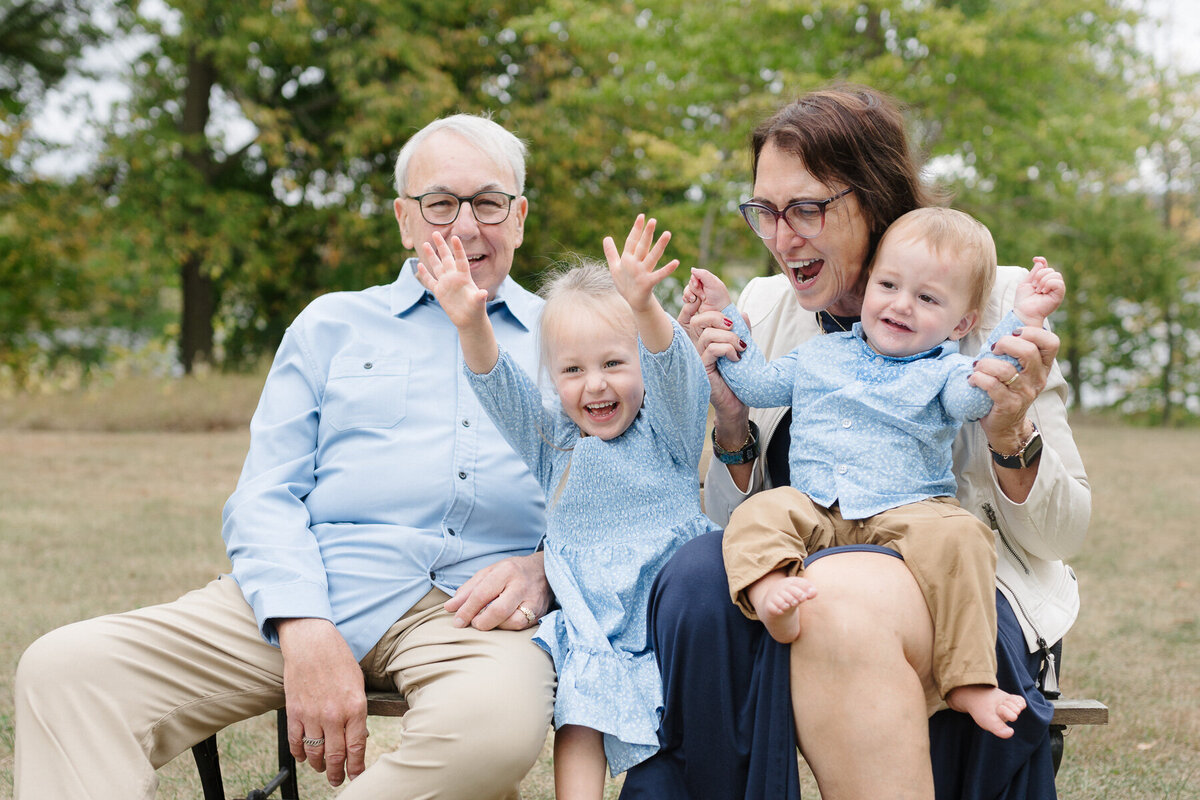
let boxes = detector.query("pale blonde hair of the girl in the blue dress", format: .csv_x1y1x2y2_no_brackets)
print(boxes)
538,255,637,369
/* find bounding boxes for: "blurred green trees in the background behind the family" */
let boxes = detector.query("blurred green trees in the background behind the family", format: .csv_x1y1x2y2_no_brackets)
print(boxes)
0,0,1200,423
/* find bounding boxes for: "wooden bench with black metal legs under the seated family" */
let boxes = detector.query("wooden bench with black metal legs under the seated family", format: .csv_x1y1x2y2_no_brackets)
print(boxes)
192,692,1109,800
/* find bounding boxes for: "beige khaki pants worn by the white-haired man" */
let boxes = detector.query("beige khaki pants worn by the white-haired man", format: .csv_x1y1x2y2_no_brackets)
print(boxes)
14,577,554,800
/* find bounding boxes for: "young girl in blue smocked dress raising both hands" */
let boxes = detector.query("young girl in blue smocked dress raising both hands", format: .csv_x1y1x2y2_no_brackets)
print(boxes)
418,215,716,800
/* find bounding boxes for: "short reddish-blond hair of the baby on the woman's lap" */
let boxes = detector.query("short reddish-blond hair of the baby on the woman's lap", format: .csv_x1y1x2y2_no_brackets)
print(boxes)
871,206,996,313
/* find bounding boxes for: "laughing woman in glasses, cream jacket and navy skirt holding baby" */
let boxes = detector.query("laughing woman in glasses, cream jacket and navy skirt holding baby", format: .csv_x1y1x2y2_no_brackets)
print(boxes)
622,86,1091,800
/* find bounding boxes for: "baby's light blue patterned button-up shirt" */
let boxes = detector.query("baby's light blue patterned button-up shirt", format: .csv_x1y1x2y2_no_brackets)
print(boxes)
718,306,1021,519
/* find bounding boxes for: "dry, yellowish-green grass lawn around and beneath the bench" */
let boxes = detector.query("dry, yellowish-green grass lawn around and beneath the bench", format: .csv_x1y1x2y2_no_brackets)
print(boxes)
0,377,1200,800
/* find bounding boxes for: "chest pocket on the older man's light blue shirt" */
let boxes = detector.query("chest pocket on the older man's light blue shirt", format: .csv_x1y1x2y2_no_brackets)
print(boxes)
320,356,409,431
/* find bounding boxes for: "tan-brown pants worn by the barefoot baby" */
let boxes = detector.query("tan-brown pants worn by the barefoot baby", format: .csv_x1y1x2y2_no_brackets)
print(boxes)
722,486,996,698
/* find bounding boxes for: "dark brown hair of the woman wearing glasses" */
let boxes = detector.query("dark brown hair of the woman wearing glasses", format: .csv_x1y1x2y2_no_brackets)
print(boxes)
751,84,937,263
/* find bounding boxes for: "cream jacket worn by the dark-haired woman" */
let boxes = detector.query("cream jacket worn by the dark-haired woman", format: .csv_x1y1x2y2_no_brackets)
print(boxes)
704,266,1092,652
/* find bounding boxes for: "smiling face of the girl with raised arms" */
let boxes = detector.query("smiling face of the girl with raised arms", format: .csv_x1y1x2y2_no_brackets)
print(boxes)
542,308,646,439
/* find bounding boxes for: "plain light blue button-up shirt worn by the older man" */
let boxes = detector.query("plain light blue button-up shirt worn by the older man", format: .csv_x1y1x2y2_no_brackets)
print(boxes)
222,259,545,658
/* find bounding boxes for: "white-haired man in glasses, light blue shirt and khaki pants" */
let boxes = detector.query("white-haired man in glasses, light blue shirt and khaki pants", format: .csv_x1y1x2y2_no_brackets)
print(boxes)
16,115,554,800
